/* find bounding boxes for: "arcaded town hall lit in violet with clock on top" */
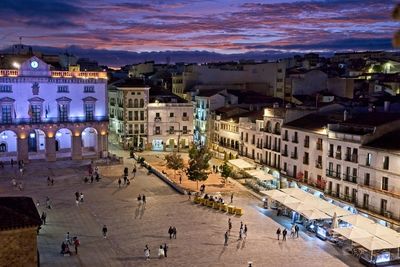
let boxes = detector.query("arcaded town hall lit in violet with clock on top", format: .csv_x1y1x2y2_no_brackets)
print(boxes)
0,57,108,162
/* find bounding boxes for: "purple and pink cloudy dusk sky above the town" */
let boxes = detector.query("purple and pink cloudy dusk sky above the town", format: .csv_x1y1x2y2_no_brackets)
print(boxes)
0,0,400,64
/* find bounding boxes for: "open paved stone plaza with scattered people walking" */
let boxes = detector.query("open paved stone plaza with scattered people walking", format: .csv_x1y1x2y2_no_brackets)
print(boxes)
0,159,360,267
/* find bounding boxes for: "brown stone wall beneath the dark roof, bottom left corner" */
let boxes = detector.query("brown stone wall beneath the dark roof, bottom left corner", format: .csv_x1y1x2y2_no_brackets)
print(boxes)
0,227,38,267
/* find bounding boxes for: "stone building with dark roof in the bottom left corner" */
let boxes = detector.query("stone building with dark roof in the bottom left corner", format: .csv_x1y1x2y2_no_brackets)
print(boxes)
0,197,42,267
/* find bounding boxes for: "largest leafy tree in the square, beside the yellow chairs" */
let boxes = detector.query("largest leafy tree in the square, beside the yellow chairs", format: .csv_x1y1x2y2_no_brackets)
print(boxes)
186,146,212,189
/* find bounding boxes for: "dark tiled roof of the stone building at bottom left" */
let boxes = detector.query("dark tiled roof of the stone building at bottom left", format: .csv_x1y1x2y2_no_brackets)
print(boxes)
0,197,42,230
